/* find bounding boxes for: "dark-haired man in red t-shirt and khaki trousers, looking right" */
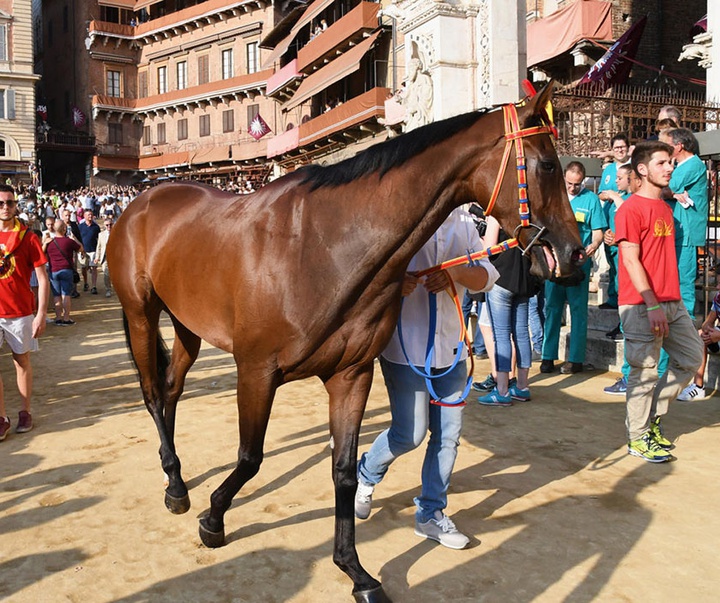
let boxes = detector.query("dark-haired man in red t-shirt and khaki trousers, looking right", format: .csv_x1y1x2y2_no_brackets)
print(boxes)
615,141,703,463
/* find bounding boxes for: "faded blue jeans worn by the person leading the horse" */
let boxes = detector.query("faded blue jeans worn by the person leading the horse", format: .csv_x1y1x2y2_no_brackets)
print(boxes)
358,357,467,523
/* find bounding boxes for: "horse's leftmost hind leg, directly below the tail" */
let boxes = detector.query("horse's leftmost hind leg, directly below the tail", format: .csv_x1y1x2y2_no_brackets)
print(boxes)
123,302,190,513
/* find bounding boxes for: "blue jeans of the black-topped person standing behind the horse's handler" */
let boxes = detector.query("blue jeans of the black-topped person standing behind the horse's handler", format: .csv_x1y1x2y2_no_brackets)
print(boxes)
487,284,532,373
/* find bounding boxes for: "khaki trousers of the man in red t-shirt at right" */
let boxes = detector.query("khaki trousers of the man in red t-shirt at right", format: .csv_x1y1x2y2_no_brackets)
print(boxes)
619,300,703,441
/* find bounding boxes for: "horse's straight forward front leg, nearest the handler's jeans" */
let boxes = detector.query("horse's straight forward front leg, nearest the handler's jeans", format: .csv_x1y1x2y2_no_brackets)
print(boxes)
325,362,390,603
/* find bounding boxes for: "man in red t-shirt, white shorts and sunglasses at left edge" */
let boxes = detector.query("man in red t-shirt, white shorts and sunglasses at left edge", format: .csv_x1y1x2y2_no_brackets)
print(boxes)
0,184,50,441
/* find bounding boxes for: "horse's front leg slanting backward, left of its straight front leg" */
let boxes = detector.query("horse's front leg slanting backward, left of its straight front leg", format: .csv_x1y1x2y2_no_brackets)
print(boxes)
199,364,280,548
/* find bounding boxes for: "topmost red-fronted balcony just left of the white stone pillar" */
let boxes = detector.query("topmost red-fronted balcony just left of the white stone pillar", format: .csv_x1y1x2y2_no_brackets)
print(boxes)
297,2,380,73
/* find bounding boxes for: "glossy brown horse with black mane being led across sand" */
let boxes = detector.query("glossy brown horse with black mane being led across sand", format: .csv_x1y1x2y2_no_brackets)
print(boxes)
108,82,585,602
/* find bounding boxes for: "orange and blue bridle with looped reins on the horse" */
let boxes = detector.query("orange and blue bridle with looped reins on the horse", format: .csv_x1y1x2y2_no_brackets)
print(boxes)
398,104,557,406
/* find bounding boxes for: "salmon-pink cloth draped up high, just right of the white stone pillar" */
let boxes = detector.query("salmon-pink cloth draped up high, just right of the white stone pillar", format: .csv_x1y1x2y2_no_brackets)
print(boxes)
527,0,613,67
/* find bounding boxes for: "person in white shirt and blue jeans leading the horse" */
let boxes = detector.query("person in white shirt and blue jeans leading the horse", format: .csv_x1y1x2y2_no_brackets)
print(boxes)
355,209,498,549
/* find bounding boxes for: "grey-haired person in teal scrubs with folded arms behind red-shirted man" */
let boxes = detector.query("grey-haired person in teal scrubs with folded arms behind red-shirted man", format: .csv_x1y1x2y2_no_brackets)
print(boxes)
660,128,708,320
